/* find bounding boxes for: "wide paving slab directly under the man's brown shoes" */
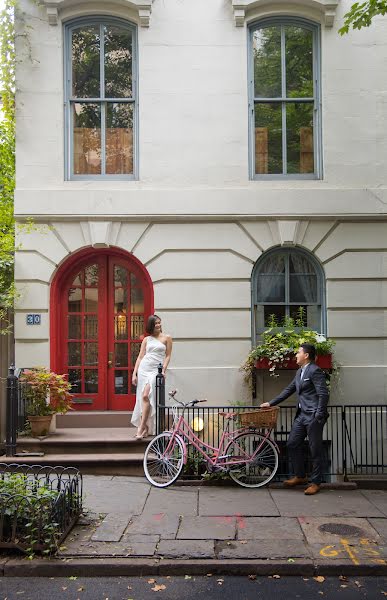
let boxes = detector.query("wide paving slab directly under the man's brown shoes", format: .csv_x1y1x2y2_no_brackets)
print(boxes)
271,489,384,517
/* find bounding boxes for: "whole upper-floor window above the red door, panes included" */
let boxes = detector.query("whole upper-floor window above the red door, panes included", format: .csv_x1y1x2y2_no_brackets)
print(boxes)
65,17,137,179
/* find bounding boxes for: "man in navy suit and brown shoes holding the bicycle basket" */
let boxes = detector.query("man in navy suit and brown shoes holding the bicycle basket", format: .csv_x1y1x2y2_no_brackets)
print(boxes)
261,344,329,496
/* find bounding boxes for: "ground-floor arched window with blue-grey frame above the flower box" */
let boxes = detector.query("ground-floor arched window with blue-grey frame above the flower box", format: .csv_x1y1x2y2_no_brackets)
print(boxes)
252,247,325,338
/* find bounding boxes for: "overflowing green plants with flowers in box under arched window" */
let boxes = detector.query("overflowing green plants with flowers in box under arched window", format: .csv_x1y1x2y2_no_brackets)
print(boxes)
241,307,335,380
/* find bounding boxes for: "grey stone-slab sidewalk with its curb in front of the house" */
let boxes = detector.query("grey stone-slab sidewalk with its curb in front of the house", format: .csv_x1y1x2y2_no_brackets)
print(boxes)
0,475,387,576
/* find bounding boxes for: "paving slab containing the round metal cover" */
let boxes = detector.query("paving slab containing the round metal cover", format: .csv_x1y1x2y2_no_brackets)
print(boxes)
298,517,381,546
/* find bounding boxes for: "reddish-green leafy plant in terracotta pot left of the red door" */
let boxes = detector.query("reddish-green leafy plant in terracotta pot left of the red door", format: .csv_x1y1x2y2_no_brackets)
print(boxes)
21,367,73,437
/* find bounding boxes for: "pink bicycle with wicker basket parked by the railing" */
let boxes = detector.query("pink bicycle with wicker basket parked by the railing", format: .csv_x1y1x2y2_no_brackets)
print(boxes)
144,391,279,488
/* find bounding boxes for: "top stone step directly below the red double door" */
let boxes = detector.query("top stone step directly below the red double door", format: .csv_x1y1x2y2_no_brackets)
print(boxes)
56,410,133,429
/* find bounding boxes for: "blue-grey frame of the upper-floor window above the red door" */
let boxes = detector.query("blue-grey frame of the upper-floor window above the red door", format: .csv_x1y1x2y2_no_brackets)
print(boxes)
63,15,139,181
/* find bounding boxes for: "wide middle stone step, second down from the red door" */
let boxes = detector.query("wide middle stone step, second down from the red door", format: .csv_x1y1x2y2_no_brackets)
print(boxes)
13,427,151,454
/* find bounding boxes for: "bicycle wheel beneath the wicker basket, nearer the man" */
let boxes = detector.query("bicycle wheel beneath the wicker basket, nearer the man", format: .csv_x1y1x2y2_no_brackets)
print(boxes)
225,431,278,487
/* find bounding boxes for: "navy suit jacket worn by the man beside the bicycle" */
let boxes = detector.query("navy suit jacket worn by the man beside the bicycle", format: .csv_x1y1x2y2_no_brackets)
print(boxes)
270,362,329,421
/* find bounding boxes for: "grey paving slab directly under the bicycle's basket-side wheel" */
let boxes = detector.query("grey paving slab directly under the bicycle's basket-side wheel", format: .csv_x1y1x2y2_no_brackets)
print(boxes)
199,488,279,516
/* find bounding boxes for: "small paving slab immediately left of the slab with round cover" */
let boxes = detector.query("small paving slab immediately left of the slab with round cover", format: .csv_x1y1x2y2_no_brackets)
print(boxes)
237,517,304,540
